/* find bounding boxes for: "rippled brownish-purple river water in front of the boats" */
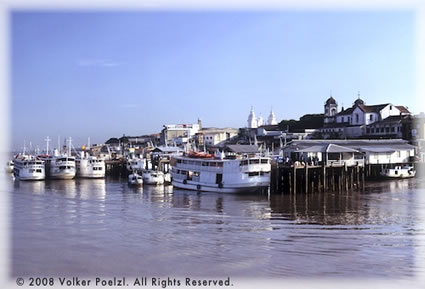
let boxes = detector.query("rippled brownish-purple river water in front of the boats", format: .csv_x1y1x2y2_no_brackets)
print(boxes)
8,174,425,278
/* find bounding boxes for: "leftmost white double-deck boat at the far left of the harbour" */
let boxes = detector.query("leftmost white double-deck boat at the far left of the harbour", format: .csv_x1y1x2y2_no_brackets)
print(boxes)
13,154,45,181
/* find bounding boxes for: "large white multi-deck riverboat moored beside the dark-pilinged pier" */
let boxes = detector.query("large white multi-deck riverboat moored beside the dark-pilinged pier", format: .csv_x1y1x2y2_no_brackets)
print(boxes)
170,153,271,193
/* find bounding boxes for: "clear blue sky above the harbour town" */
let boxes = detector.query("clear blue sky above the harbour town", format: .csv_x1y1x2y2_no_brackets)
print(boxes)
11,11,418,149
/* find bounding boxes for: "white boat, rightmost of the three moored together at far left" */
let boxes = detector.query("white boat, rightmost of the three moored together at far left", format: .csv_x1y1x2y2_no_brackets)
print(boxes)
75,151,106,179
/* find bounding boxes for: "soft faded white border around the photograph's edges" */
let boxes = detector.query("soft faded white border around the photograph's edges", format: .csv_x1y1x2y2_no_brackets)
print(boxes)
0,0,425,289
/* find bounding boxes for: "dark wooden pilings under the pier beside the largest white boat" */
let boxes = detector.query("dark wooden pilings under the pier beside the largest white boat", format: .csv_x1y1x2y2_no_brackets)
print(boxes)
270,164,366,194
